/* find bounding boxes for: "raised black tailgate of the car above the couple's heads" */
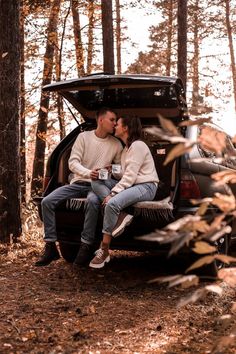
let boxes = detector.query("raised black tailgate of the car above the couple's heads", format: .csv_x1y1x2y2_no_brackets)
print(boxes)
43,75,187,124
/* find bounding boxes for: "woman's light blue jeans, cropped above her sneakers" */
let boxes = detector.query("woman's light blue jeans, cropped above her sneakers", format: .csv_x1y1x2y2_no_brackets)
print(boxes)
91,180,157,235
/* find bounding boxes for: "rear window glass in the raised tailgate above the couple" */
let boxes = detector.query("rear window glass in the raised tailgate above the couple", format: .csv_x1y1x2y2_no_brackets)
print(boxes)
70,86,178,110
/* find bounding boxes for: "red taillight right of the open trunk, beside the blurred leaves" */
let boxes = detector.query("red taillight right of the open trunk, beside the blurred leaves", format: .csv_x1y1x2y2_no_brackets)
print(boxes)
180,172,201,199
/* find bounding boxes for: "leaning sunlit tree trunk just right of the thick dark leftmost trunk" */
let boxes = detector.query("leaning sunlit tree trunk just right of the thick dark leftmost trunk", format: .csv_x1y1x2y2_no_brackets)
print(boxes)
31,0,61,196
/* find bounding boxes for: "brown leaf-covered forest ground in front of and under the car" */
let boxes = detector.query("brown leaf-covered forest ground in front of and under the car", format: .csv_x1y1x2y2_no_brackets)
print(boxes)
0,212,236,354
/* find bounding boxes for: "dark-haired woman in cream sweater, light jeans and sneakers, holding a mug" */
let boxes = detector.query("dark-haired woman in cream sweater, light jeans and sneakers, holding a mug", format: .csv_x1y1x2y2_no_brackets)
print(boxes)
89,116,159,268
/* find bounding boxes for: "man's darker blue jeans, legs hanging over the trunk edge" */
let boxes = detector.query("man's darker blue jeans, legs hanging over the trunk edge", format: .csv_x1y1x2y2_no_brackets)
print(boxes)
42,183,101,244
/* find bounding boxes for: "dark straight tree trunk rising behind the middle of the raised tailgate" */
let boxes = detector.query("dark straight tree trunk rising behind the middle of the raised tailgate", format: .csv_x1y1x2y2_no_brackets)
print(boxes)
102,0,115,74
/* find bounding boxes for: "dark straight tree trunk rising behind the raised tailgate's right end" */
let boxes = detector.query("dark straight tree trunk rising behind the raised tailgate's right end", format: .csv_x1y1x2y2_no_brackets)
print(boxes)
177,0,187,90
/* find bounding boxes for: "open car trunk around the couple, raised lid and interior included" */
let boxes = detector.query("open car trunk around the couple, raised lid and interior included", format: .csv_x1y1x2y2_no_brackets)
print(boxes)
40,75,188,261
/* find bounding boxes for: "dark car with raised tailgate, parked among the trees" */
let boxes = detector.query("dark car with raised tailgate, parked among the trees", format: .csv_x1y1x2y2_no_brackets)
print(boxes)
37,74,235,272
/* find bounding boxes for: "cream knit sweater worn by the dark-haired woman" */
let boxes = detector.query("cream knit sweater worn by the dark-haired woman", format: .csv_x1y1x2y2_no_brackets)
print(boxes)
112,140,159,193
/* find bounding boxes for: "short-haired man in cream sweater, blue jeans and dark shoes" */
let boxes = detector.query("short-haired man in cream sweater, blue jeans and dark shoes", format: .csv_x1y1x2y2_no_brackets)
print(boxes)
35,108,122,266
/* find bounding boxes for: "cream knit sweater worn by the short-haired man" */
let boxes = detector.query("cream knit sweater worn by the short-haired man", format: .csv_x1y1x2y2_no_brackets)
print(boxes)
68,130,122,183
